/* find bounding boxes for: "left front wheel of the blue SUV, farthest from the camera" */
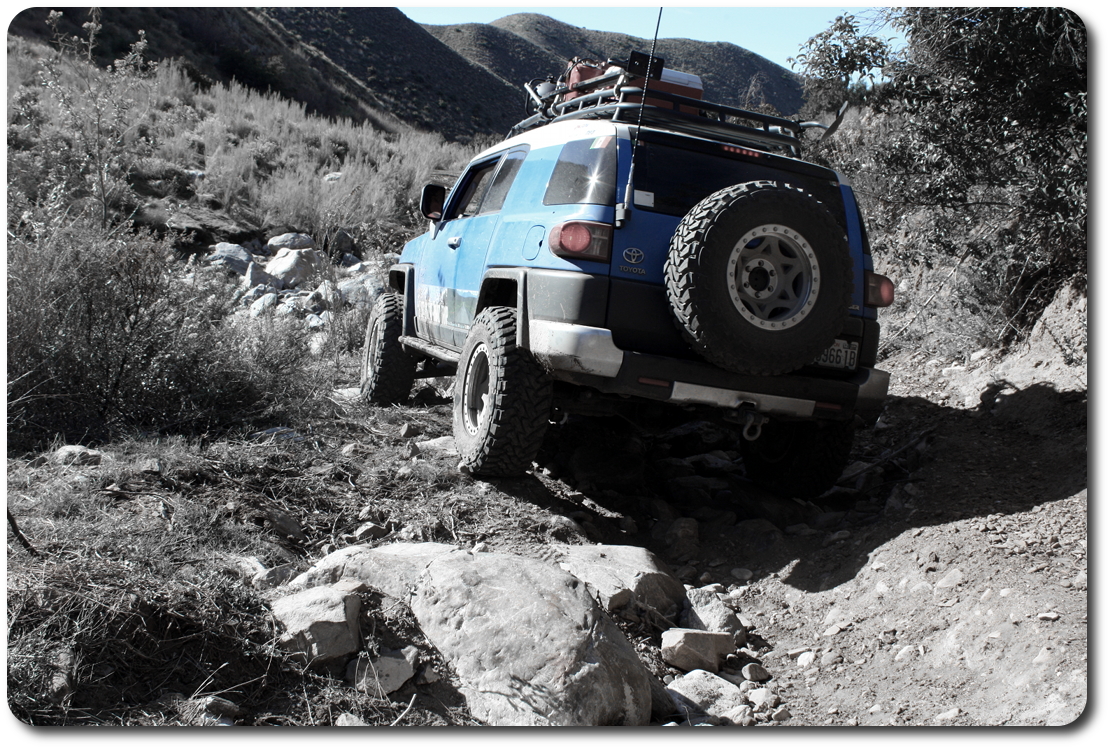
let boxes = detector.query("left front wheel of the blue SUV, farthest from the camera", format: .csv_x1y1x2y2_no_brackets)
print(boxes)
360,292,416,406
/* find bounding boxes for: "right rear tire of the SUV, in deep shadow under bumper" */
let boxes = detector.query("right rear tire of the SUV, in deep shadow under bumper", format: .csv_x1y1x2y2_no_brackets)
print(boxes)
743,422,856,499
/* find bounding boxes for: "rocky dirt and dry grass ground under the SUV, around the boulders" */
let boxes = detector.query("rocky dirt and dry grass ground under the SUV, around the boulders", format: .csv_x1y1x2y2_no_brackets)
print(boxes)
9,282,1088,726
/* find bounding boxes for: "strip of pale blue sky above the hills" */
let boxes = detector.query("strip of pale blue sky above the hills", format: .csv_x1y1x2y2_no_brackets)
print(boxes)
401,4,895,72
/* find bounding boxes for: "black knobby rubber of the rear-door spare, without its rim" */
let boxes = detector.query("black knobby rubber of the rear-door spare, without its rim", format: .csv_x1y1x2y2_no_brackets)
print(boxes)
664,181,852,375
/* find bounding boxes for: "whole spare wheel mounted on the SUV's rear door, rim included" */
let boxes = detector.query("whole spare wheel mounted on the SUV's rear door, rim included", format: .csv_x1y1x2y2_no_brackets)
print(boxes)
666,181,851,375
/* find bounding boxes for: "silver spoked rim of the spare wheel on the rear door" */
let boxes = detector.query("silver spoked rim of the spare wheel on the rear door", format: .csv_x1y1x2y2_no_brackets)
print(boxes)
728,224,820,331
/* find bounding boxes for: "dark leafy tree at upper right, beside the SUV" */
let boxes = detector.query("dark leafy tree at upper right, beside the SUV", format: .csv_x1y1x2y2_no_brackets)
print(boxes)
798,8,1087,335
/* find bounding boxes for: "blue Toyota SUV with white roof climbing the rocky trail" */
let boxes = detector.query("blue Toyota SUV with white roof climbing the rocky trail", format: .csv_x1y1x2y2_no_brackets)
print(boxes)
362,53,894,497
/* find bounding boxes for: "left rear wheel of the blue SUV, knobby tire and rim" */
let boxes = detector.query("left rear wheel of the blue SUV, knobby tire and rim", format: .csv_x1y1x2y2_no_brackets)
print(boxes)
453,307,552,476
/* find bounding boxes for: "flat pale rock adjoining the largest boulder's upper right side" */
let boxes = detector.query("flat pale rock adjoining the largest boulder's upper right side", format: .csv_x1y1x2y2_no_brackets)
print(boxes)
551,544,686,618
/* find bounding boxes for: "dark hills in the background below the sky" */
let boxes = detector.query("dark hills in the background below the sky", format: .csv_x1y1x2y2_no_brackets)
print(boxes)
9,7,801,141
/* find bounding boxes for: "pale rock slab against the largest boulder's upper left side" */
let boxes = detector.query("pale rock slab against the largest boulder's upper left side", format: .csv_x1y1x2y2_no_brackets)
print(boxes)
290,541,462,600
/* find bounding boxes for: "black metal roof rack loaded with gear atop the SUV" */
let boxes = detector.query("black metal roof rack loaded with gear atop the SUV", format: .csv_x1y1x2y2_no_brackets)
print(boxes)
509,55,808,155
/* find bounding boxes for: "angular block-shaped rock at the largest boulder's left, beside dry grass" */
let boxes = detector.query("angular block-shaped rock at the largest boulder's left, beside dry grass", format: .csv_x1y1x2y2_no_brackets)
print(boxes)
271,586,360,662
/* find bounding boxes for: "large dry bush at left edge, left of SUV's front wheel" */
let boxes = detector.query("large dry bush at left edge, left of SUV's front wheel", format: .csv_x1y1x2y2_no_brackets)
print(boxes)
8,214,319,450
